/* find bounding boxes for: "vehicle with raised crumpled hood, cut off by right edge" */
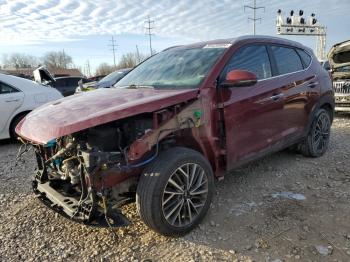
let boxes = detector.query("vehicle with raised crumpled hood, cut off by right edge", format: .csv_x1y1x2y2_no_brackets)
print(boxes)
328,40,350,112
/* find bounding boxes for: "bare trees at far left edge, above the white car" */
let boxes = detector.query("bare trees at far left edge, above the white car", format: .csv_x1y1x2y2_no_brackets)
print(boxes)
2,53,40,68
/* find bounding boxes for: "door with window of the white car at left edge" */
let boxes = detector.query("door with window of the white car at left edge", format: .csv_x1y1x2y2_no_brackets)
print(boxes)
0,81,24,133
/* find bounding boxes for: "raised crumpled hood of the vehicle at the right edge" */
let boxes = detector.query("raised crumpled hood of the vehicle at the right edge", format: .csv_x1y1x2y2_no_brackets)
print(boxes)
328,40,350,69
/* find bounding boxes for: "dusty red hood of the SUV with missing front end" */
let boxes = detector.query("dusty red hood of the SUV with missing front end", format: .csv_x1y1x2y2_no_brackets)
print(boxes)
16,88,198,144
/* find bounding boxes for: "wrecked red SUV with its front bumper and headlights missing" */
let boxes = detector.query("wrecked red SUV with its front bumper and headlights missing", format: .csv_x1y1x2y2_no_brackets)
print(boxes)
16,36,334,236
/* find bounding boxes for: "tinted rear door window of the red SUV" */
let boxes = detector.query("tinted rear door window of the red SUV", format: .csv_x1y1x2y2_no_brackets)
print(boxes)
271,46,303,75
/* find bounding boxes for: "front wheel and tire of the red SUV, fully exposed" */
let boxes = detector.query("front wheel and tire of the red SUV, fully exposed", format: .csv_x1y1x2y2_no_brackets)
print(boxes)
136,147,214,236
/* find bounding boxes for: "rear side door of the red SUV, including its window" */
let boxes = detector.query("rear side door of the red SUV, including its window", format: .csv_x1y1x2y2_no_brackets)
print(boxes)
268,45,319,141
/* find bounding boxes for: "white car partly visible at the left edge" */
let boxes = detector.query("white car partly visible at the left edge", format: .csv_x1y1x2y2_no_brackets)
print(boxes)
0,74,63,139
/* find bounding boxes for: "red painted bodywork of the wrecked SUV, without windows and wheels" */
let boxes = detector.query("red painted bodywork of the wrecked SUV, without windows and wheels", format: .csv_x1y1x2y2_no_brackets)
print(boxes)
16,36,334,176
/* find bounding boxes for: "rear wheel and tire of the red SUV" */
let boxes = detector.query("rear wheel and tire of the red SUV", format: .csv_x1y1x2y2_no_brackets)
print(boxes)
300,109,332,157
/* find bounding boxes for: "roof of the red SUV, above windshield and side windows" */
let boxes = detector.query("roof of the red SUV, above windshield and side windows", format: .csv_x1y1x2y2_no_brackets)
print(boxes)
165,35,311,50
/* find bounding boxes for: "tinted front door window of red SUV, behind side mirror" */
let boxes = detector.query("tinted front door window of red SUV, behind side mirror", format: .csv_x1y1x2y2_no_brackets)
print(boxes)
220,45,271,80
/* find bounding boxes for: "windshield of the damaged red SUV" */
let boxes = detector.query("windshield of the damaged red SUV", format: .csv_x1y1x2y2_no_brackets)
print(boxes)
115,45,228,89
